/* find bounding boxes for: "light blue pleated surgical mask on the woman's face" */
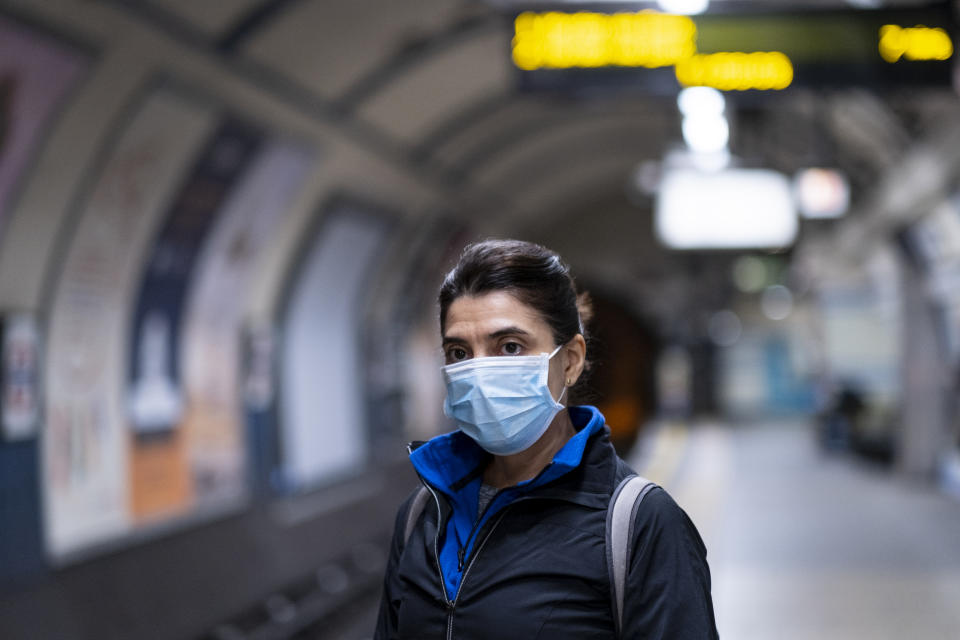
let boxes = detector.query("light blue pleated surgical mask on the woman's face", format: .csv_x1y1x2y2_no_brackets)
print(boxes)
443,347,566,456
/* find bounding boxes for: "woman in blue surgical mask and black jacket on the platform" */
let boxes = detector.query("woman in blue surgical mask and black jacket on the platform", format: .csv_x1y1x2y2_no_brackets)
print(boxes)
375,240,717,640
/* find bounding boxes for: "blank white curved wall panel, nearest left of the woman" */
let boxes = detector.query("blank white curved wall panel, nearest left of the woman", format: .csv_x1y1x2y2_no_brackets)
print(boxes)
278,209,387,489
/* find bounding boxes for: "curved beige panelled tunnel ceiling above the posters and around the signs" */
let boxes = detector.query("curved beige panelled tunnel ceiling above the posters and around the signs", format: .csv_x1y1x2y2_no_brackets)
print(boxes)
7,0,952,322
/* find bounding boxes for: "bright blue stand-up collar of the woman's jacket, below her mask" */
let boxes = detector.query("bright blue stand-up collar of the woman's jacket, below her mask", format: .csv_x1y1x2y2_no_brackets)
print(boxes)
410,406,604,496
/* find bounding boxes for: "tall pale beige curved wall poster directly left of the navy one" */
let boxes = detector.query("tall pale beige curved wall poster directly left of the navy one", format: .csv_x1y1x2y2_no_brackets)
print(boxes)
41,92,215,558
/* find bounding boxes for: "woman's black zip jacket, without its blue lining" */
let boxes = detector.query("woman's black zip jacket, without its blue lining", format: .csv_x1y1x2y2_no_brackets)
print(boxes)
374,427,717,640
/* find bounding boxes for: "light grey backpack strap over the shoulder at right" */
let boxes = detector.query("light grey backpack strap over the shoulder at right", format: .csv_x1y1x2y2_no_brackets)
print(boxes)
607,475,657,638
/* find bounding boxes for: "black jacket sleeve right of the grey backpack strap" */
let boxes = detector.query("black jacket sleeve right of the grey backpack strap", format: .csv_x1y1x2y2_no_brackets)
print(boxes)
621,488,718,640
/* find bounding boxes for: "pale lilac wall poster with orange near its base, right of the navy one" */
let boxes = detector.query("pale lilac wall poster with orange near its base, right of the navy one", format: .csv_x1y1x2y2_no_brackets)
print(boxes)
165,142,311,508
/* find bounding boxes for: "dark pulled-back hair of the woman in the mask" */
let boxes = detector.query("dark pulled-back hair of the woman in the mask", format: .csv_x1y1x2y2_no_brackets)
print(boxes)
438,240,592,345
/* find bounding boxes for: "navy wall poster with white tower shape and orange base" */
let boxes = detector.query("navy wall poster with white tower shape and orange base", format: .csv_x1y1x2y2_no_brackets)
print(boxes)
127,120,263,522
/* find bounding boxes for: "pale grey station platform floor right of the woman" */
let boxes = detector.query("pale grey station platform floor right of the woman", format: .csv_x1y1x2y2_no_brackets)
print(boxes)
323,420,960,640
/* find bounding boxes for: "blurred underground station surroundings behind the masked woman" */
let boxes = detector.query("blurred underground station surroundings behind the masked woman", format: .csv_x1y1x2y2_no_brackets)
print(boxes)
0,0,960,640
